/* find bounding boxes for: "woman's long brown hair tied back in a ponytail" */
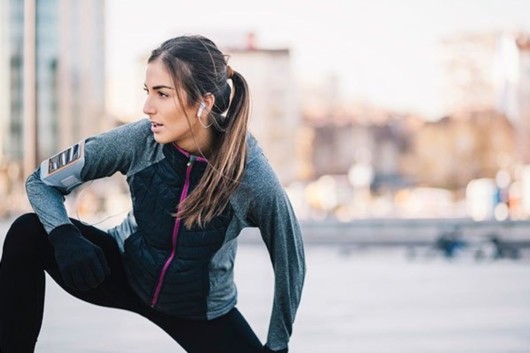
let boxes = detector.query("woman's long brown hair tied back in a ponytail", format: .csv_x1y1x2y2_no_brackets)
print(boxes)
148,35,250,228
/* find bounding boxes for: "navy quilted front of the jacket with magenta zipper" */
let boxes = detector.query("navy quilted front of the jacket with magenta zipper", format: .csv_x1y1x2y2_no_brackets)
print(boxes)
125,145,232,319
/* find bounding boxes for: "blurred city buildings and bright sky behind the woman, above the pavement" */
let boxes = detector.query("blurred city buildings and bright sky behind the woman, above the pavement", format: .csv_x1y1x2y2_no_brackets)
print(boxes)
0,0,530,226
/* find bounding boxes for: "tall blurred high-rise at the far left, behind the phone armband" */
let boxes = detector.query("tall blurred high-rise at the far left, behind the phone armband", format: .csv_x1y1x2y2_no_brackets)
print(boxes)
0,0,105,175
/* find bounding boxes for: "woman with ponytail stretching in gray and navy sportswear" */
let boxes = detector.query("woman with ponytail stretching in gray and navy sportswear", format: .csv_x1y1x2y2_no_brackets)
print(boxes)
0,36,305,353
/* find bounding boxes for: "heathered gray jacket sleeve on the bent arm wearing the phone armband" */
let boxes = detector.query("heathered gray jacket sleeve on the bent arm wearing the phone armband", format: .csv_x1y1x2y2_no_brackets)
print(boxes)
26,121,149,234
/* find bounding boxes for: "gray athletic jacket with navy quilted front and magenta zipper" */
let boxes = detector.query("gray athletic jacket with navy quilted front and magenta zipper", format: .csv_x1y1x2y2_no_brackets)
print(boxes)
26,119,305,350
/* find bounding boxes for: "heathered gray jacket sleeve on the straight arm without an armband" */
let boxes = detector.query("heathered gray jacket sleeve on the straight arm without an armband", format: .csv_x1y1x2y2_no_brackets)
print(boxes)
249,172,306,350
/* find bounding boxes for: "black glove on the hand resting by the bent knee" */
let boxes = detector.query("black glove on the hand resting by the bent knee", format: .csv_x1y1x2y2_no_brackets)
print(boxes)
49,224,110,290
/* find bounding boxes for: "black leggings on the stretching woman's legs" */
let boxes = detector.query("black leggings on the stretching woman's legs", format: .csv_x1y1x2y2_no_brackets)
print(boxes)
0,214,262,353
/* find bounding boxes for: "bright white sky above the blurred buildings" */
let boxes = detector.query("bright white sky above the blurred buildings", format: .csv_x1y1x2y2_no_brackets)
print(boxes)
106,0,530,118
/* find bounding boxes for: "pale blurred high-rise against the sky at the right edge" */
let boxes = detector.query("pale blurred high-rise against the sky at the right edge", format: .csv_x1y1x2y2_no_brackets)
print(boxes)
441,32,530,164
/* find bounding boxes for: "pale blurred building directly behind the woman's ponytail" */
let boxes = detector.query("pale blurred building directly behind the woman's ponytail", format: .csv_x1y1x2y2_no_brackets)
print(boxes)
221,34,301,184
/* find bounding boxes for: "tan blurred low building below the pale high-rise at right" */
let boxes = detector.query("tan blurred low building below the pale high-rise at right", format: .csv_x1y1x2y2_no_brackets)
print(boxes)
406,109,515,190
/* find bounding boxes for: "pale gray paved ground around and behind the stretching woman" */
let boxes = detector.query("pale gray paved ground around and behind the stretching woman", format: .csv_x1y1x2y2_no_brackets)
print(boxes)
0,219,530,353
